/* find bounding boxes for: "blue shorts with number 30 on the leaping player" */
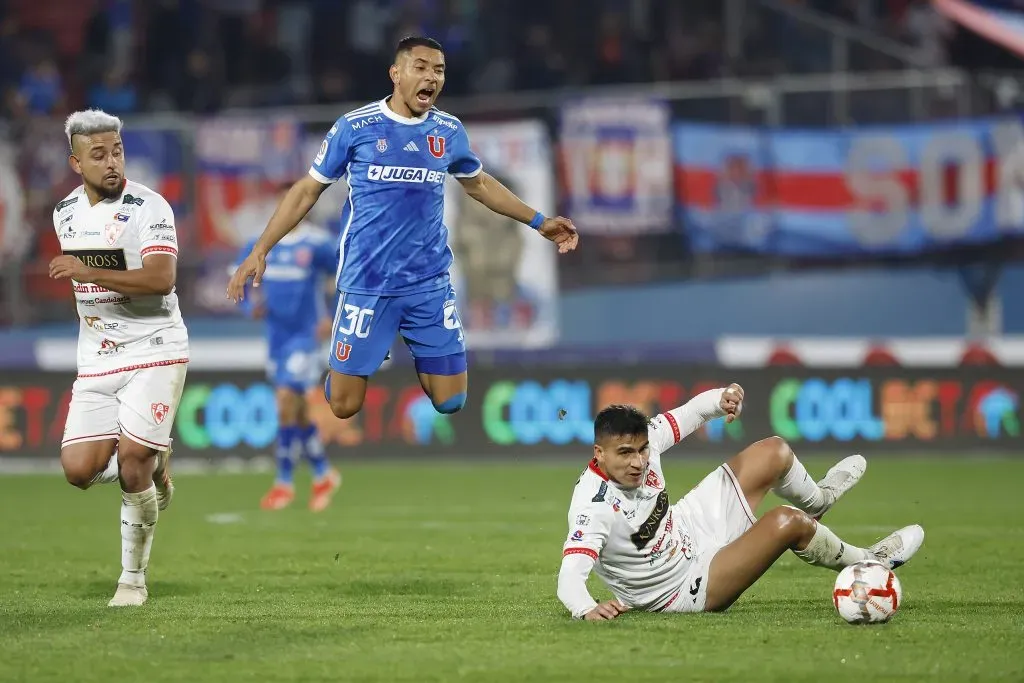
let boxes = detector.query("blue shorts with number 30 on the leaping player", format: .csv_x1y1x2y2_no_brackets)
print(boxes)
331,285,466,377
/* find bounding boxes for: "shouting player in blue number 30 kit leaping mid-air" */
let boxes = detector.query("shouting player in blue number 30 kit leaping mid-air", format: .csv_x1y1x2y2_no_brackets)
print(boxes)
227,38,580,418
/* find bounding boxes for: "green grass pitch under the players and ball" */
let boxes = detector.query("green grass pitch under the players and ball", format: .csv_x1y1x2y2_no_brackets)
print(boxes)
0,454,1024,683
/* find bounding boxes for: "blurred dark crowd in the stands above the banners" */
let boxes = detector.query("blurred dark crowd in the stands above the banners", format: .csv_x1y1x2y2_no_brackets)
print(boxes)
0,0,983,120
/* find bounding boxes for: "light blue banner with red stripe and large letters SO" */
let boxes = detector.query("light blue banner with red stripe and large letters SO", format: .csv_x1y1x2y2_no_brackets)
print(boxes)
674,118,1024,257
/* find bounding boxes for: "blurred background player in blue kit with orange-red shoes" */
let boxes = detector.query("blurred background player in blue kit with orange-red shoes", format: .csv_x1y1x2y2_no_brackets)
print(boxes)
232,188,341,512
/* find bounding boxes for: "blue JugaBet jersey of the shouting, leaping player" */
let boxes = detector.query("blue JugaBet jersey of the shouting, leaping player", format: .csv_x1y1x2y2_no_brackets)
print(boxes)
309,99,482,296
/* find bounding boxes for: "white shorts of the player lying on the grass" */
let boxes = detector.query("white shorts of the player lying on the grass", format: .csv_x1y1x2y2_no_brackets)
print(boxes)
657,465,757,612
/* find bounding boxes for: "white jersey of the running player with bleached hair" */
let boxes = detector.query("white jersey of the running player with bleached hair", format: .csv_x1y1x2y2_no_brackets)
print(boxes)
53,180,188,377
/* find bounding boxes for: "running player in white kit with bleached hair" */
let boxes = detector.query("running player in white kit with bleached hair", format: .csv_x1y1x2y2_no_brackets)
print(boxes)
49,111,188,607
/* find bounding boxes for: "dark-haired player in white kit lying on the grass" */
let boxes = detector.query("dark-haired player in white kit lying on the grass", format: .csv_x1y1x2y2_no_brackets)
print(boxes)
558,384,925,621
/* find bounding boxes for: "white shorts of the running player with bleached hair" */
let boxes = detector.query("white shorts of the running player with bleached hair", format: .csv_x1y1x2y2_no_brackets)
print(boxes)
60,362,188,451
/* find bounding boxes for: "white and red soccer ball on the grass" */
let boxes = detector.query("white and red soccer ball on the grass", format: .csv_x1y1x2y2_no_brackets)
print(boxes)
833,561,903,624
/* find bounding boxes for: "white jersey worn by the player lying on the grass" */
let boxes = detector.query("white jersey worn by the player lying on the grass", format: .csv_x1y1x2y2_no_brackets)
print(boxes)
562,413,697,609
